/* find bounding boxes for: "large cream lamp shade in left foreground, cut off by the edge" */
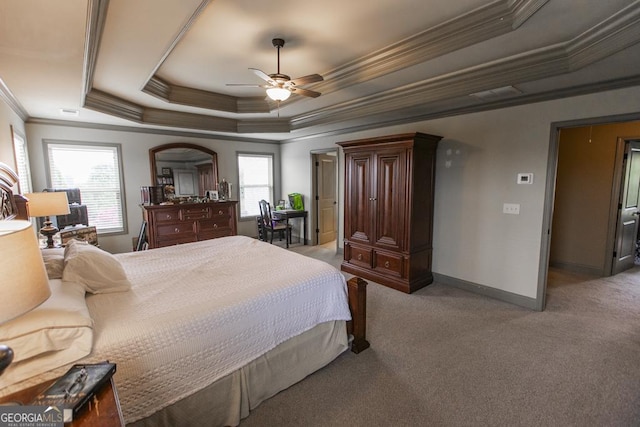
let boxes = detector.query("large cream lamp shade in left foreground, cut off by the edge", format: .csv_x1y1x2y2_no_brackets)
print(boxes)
0,220,51,324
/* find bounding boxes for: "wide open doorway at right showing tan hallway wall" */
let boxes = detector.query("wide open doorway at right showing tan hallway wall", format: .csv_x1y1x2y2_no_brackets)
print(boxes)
537,117,640,310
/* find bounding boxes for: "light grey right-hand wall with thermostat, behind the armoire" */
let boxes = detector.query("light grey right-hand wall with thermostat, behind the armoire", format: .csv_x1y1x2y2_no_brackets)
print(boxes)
281,87,640,299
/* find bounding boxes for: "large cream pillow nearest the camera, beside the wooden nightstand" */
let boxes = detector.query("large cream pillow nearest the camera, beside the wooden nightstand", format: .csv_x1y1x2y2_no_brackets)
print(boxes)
0,280,93,389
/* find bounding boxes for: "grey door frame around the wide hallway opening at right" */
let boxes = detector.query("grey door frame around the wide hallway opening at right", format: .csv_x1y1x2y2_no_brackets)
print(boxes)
535,113,640,311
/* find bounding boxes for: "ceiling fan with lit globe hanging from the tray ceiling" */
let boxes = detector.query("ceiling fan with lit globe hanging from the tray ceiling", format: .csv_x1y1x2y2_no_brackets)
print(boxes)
227,39,324,102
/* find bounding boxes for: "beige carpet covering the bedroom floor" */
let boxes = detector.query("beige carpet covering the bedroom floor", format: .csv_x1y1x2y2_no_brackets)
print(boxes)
242,245,640,427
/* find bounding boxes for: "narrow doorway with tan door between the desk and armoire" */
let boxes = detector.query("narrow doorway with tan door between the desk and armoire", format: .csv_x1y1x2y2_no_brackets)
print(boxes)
310,150,338,251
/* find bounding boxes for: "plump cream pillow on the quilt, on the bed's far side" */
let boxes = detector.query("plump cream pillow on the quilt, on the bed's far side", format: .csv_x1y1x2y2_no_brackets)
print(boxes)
62,240,131,294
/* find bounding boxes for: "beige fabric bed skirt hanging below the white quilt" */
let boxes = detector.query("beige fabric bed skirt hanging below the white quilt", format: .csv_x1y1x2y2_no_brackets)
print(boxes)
127,320,349,427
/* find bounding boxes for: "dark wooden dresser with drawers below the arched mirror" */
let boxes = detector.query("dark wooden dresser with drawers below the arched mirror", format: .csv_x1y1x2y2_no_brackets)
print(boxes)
142,200,238,249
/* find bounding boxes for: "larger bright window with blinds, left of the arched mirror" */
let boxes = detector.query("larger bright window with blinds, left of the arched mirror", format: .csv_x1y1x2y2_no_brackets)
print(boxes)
45,142,126,234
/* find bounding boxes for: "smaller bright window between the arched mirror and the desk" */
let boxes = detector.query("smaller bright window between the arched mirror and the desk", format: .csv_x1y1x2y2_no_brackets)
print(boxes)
238,153,273,219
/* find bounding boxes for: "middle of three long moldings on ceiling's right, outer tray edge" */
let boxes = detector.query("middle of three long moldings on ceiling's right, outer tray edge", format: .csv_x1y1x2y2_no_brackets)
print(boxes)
291,4,640,130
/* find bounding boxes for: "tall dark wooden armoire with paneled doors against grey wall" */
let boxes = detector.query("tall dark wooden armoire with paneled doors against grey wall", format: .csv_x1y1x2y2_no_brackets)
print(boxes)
338,133,442,293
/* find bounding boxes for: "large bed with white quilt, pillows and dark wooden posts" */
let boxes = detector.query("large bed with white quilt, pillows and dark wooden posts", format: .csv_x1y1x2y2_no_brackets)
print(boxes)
0,163,369,426
